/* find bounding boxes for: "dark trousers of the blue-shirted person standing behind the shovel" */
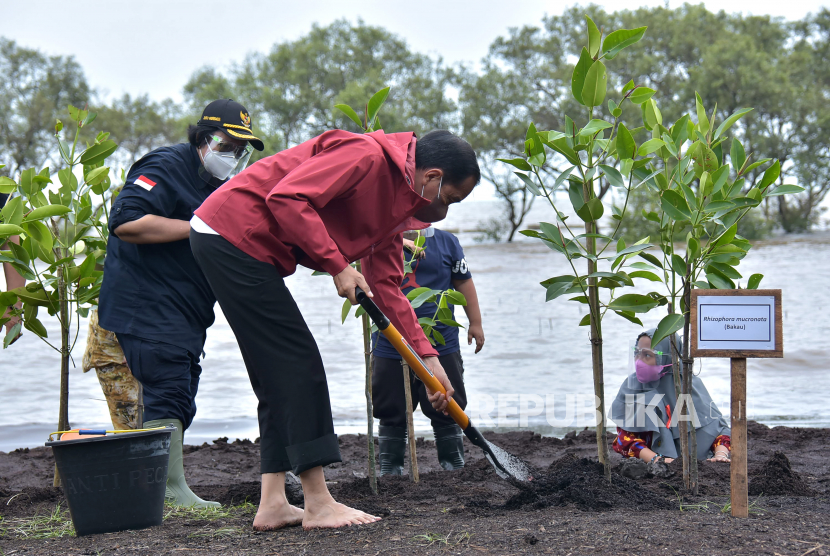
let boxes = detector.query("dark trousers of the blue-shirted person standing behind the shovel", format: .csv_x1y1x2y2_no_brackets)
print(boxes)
372,351,467,428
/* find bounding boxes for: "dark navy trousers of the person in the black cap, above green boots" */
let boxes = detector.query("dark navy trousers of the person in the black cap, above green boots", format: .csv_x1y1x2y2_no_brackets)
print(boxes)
116,334,202,430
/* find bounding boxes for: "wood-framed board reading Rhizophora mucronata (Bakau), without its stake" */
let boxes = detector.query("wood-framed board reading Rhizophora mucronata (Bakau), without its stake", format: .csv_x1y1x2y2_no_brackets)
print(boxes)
690,290,784,358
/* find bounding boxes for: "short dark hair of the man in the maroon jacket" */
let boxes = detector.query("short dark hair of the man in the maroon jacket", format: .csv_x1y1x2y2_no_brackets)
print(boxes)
415,129,481,185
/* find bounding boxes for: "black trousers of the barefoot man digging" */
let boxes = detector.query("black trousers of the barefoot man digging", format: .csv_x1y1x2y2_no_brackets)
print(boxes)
190,230,342,475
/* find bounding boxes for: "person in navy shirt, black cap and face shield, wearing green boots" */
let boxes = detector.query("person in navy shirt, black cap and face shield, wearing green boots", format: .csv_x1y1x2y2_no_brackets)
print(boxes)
98,99,263,507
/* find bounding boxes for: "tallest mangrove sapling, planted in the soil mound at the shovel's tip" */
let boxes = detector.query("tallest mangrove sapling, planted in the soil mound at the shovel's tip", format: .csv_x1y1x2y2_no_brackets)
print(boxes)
502,16,667,480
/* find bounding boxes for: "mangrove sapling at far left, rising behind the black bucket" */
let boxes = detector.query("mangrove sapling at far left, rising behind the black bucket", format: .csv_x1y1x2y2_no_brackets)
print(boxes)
0,106,117,486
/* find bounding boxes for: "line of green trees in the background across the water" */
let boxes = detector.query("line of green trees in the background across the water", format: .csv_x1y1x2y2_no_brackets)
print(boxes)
0,4,830,241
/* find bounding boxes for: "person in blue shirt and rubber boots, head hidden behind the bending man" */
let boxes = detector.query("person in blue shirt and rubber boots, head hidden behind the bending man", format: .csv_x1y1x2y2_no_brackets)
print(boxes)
372,228,484,475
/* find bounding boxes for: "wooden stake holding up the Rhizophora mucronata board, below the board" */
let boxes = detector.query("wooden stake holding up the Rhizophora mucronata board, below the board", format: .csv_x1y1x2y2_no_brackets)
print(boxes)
730,357,749,517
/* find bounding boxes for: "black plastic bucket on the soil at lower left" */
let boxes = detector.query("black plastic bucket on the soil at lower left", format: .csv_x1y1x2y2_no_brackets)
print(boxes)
46,429,172,537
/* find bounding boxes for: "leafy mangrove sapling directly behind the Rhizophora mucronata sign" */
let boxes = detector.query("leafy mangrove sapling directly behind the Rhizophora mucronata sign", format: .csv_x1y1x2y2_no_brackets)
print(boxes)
634,95,803,494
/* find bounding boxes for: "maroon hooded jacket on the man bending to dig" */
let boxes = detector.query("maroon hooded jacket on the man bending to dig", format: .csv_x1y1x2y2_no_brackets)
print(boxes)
196,130,437,356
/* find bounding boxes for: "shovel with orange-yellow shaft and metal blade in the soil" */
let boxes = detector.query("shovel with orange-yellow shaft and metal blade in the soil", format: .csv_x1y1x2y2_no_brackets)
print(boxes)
356,288,533,481
